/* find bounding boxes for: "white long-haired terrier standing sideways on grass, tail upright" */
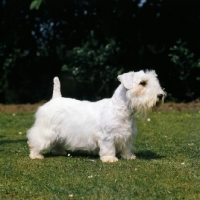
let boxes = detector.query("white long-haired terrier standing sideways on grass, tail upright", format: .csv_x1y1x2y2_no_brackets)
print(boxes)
27,71,166,162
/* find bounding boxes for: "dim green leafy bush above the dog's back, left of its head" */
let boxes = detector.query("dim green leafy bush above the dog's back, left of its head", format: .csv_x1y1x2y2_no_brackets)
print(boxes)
62,31,123,84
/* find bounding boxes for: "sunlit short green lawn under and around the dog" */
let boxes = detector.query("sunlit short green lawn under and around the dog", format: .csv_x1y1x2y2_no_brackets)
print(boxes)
0,111,200,200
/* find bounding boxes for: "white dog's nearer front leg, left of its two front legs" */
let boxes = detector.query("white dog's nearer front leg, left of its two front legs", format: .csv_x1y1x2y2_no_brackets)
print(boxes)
99,138,118,162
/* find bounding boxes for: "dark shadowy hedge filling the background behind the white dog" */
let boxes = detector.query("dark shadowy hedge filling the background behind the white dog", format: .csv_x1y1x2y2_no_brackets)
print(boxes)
0,0,200,103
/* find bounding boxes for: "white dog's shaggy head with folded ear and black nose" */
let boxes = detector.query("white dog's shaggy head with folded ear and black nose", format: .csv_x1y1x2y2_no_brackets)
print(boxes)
118,70,166,117
